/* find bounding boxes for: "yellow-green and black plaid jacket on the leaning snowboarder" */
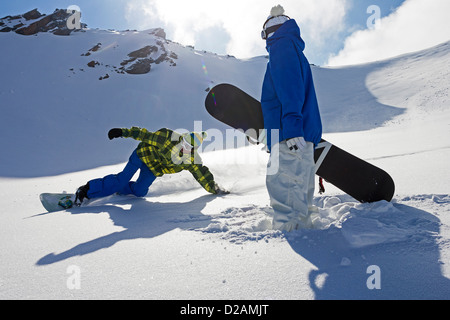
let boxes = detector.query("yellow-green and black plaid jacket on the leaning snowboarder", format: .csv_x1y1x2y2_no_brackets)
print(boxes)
122,127,216,193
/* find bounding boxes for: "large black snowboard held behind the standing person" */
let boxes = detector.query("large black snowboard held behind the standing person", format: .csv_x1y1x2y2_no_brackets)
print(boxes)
205,84,395,202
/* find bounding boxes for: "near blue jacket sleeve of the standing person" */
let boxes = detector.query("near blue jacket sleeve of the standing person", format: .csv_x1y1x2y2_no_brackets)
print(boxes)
269,39,306,139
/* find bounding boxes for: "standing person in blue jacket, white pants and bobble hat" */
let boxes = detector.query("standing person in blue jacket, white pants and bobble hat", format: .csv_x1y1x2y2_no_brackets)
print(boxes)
261,5,322,231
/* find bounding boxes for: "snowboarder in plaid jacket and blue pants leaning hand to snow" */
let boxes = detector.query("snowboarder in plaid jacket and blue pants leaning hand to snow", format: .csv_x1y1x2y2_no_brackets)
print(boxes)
75,127,227,205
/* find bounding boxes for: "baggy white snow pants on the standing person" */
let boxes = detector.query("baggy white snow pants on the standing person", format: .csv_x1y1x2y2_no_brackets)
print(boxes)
266,141,315,231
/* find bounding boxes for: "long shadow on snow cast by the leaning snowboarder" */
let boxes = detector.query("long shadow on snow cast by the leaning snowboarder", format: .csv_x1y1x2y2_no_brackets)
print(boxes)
36,195,214,266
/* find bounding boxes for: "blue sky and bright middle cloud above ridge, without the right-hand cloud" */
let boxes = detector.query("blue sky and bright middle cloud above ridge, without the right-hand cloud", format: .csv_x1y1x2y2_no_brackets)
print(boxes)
0,0,450,65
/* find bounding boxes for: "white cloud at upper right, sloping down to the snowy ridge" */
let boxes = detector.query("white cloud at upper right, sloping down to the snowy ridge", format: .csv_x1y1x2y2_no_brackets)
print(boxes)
328,0,450,66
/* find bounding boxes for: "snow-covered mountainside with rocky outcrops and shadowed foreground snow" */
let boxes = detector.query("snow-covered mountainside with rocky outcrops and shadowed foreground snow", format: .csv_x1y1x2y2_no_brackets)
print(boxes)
0,9,450,304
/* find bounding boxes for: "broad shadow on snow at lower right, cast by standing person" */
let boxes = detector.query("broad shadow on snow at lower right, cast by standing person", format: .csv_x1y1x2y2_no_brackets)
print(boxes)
287,198,450,300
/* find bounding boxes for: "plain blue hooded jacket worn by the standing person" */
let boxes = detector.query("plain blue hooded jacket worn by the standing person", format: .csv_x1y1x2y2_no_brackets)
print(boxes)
261,19,322,148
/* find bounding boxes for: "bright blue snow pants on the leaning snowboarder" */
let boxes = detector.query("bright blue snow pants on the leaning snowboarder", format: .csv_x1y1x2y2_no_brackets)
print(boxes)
87,150,156,199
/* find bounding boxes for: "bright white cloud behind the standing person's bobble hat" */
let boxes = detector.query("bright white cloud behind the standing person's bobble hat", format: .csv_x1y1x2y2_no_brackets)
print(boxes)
126,0,349,58
